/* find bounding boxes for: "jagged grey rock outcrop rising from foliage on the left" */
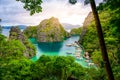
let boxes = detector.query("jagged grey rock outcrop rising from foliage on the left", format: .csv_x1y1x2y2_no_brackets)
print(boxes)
9,27,36,58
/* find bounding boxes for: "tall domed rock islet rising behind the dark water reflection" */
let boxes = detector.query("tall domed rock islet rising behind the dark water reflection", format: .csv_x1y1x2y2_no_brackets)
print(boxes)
37,17,68,42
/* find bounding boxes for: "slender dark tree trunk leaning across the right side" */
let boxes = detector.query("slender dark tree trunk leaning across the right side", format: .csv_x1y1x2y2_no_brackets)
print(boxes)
90,0,114,80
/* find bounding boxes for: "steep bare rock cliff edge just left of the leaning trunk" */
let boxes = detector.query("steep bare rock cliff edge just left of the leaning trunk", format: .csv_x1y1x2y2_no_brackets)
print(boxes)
79,12,94,43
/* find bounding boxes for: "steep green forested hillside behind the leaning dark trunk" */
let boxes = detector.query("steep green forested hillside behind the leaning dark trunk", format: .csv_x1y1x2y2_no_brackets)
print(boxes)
82,0,120,80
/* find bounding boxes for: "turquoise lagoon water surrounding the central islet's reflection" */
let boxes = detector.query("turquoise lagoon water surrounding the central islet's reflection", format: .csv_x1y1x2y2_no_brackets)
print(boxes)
30,36,88,67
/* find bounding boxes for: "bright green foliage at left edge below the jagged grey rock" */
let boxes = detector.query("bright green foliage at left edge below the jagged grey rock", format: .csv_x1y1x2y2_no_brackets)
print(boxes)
0,34,26,58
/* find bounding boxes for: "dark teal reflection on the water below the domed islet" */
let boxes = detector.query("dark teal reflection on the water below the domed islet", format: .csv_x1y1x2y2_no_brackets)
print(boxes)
38,42,63,53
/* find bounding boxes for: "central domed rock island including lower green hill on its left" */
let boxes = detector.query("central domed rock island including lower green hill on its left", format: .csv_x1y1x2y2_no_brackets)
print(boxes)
24,17,69,42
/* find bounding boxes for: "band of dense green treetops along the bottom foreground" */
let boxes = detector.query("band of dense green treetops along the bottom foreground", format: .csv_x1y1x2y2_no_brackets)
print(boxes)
0,48,101,80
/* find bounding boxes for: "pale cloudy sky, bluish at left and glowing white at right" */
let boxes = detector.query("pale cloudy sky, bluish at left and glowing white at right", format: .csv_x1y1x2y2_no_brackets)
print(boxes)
0,0,102,26
